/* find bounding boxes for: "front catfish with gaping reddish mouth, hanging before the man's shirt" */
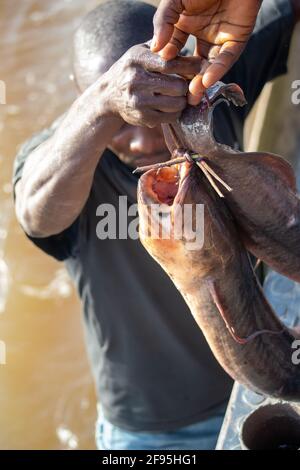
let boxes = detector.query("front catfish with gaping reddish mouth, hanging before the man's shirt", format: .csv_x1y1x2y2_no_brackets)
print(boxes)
138,163,300,401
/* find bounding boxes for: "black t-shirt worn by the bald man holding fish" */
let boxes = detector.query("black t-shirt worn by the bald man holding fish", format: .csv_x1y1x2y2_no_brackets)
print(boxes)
13,0,294,431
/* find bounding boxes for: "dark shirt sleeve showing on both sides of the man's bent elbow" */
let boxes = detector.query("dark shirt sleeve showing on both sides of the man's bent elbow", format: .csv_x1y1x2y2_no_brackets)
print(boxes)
12,116,79,261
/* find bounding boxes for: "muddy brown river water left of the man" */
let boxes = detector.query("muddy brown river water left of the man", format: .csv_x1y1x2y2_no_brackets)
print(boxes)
0,0,117,449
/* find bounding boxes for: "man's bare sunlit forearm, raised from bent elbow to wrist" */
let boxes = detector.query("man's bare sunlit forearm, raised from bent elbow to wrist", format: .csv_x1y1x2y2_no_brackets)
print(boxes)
16,80,123,237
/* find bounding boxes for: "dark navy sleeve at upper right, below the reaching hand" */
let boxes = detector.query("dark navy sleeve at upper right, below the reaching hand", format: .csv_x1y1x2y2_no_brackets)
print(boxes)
225,0,296,118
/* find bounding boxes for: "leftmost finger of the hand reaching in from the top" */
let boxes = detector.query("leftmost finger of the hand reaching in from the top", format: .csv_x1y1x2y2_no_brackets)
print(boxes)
151,0,183,52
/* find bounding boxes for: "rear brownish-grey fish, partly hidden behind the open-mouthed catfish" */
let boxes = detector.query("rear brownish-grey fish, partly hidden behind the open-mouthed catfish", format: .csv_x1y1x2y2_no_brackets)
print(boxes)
165,82,300,282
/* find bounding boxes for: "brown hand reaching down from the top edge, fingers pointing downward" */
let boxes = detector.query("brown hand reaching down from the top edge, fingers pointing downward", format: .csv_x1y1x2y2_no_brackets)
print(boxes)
151,0,261,104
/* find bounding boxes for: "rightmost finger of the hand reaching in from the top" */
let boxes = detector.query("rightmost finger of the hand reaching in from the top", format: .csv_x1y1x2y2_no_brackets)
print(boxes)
202,41,245,88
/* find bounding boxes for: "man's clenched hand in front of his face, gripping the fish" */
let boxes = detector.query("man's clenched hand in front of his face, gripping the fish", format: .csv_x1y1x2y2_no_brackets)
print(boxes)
100,44,201,127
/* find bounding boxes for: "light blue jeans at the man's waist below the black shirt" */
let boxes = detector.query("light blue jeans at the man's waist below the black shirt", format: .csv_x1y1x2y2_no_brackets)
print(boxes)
96,406,226,450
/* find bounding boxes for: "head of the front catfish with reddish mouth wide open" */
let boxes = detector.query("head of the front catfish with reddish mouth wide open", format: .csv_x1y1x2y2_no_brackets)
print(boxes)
138,162,230,287
